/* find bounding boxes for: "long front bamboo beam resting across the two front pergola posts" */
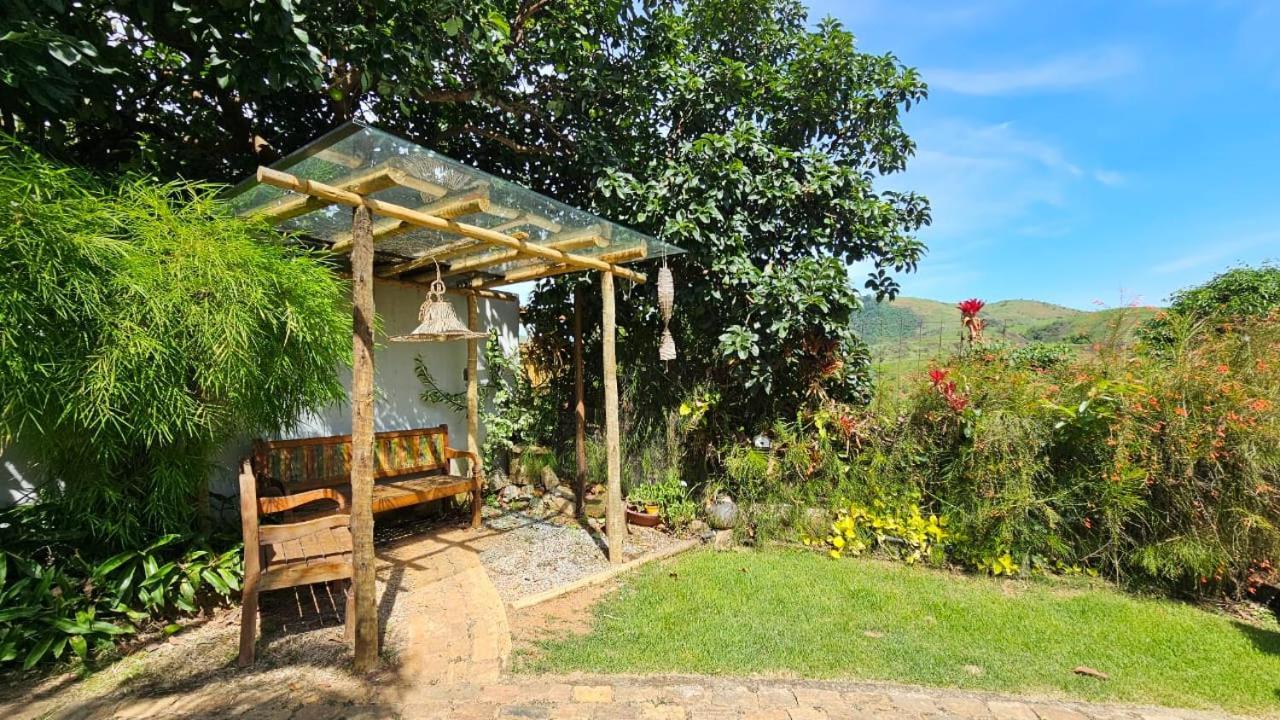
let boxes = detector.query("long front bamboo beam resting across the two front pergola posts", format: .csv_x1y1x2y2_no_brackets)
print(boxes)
257,167,646,283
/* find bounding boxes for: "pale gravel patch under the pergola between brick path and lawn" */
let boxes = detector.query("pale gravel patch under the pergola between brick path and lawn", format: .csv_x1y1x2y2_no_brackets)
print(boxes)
480,506,680,602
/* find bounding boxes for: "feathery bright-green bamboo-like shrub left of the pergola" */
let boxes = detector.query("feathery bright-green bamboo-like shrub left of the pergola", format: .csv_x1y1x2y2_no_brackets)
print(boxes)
0,138,351,552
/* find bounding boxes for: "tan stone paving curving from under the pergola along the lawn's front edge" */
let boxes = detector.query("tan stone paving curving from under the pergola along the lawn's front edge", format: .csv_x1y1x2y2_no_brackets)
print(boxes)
17,520,1226,720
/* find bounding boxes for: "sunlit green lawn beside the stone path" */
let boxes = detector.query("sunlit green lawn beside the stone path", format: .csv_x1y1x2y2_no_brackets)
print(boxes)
518,551,1280,715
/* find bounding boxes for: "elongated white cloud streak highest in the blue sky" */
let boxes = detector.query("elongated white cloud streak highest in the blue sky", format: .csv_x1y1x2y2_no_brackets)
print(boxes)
923,47,1138,95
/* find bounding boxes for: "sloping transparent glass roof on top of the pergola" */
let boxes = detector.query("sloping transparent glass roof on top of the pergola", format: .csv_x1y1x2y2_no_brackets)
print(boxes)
229,123,684,275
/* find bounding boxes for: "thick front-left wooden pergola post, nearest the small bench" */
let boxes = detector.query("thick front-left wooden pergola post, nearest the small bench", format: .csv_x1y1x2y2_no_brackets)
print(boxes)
351,208,378,673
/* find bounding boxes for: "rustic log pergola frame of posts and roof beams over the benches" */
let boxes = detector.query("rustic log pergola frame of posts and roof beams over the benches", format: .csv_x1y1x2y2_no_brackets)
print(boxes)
226,128,680,673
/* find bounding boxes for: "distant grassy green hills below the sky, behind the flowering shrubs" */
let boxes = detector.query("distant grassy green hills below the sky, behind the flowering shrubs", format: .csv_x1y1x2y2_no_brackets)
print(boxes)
854,297,1157,379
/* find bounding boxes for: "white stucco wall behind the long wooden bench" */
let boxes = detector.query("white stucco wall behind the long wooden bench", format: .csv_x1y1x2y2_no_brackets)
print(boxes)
0,278,520,505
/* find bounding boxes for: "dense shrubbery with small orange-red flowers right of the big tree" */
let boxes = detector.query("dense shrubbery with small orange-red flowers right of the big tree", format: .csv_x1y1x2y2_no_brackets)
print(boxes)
854,308,1280,593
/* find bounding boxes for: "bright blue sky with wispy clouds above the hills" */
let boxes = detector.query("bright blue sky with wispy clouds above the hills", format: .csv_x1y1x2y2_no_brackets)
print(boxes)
810,0,1280,309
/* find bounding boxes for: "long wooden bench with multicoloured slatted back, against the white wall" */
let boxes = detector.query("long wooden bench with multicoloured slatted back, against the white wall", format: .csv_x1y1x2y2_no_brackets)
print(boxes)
253,425,481,528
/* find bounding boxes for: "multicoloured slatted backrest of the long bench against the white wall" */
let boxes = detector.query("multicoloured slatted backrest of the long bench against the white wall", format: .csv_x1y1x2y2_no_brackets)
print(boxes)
252,425,449,495
